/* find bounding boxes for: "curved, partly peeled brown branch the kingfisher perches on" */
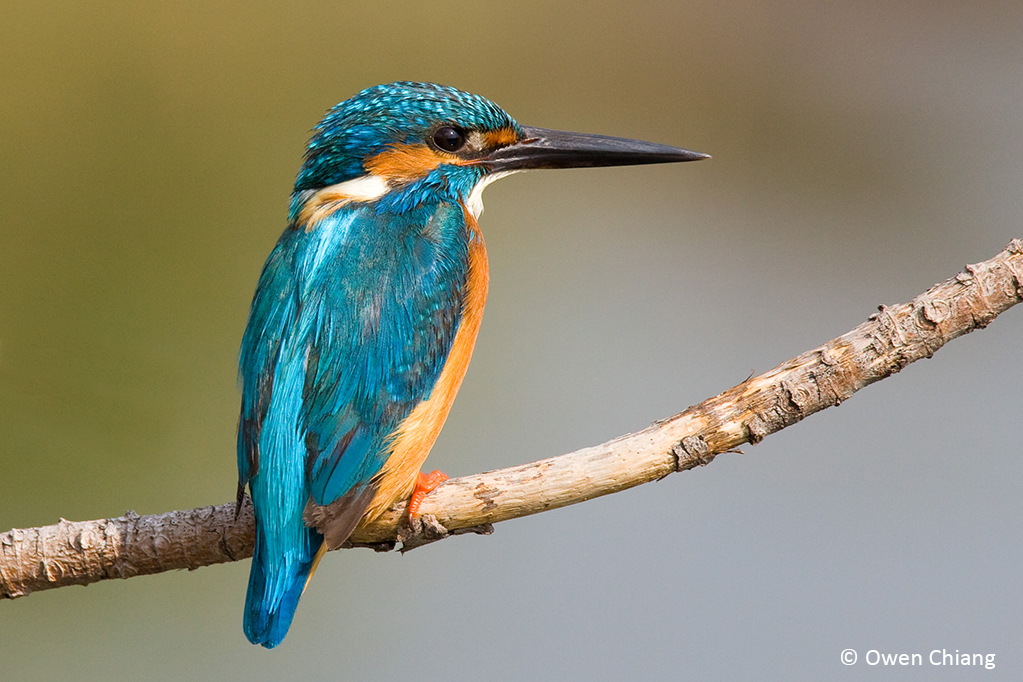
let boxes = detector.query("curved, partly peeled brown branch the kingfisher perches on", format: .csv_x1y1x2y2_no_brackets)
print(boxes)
0,239,1023,599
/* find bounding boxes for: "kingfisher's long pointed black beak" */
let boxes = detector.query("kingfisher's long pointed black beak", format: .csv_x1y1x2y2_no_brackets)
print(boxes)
482,126,710,173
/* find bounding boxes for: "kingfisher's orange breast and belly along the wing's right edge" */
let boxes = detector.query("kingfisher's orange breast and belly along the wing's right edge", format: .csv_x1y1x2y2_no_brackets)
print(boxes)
362,207,490,524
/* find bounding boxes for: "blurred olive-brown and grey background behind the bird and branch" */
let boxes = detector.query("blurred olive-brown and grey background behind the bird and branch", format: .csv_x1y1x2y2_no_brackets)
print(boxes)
0,0,1023,681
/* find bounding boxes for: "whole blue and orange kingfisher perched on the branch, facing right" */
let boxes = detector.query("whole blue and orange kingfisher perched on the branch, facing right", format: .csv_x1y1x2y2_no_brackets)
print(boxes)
237,81,708,648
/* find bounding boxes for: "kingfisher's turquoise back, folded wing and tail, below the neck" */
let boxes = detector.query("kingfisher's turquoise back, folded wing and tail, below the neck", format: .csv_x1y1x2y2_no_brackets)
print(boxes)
238,203,469,646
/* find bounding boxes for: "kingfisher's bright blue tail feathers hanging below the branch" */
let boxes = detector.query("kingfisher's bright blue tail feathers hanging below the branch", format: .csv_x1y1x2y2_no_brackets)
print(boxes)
243,530,323,649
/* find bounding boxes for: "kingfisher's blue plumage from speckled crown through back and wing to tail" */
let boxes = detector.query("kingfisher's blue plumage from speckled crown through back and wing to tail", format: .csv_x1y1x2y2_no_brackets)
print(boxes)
238,83,520,647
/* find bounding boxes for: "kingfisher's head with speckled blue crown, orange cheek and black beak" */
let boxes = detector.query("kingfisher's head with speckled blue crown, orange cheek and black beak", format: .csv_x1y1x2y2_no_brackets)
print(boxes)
292,82,707,220
